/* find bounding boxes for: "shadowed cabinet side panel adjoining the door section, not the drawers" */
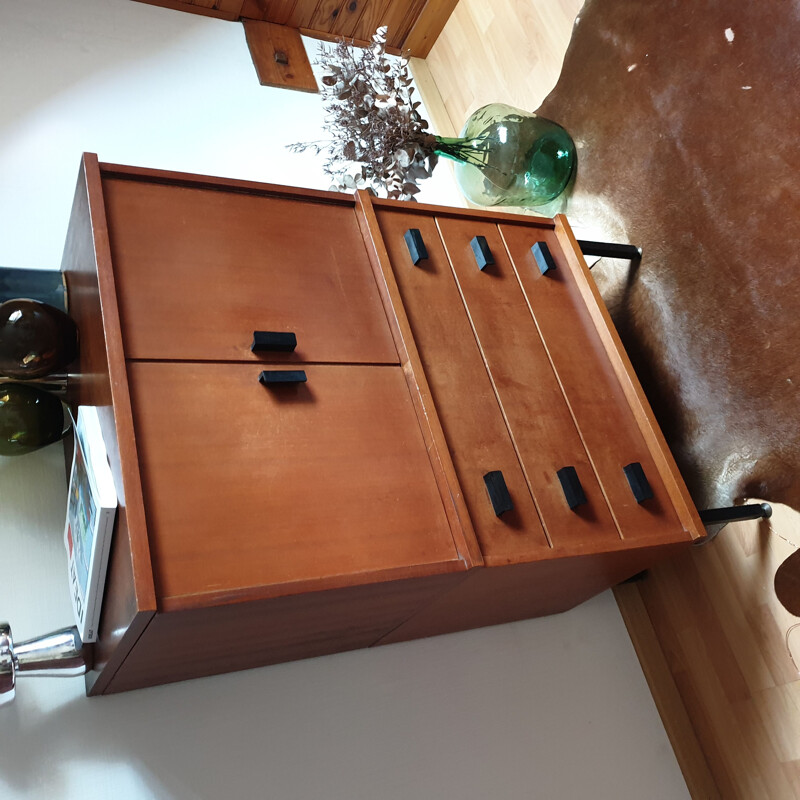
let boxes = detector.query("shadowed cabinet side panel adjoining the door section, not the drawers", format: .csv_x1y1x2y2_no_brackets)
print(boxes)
101,573,465,693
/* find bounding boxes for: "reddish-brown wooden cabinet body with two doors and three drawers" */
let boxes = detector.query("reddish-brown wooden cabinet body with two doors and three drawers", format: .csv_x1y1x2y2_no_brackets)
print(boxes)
62,155,703,694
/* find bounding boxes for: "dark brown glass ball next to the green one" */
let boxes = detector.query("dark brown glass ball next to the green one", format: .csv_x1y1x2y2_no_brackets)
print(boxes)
0,299,78,380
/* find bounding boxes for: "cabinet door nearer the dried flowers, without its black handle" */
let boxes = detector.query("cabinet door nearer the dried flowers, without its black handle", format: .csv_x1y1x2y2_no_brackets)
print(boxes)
103,179,398,363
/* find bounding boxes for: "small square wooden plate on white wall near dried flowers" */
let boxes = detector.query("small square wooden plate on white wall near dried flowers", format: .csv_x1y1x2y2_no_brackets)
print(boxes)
243,20,319,92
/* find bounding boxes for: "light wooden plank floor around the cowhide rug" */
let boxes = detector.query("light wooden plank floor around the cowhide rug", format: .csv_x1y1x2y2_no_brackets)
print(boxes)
413,0,800,800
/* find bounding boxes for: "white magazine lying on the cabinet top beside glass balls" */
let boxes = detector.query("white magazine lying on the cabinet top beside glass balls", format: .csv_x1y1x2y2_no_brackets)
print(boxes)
64,406,117,642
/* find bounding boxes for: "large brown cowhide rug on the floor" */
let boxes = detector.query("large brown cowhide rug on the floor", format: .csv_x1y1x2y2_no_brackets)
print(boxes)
538,0,800,509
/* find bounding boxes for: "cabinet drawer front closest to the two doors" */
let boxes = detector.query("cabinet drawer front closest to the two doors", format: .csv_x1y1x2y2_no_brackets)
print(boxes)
377,209,549,563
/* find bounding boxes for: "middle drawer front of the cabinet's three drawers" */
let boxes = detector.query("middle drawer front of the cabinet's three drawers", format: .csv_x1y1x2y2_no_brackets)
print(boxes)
437,217,619,552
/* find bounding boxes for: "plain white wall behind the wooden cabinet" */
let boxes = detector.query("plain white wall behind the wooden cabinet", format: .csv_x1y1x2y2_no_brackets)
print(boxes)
0,0,688,800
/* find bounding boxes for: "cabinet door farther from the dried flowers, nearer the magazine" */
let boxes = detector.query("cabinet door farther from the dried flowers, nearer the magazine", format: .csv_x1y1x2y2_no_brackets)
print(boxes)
128,362,459,607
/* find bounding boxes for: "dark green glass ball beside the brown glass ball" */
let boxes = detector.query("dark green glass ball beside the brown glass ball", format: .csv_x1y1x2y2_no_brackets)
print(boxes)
0,383,70,456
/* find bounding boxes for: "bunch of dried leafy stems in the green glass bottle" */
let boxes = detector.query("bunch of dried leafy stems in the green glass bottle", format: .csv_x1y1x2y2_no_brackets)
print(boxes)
289,27,437,200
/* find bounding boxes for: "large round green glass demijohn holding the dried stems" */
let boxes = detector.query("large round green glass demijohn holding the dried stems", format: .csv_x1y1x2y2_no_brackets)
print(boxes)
435,103,577,206
